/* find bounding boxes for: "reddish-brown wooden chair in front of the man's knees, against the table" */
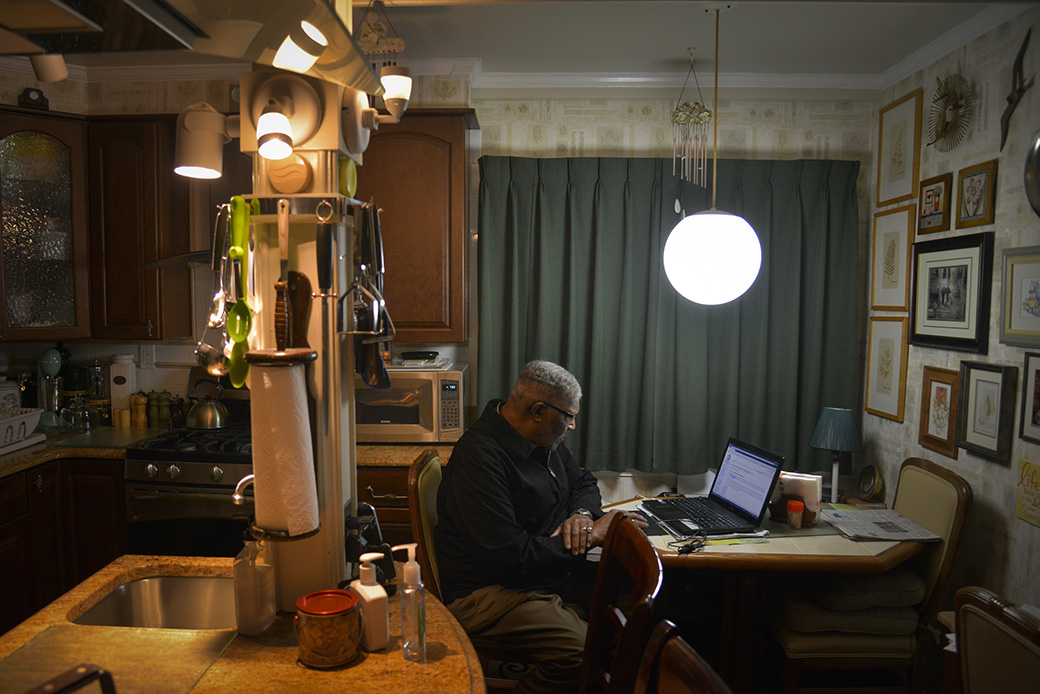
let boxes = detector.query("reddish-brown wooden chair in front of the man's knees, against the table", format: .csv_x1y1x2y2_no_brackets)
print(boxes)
580,514,662,694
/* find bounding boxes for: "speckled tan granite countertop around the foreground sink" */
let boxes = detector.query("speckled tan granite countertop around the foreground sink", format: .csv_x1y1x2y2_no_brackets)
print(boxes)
0,555,485,694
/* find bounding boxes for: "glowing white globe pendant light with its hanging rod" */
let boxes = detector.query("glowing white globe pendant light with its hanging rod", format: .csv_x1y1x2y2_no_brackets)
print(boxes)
665,9,762,305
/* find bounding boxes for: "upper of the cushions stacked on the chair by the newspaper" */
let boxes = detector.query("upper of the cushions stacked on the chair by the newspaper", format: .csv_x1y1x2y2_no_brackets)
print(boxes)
805,566,926,610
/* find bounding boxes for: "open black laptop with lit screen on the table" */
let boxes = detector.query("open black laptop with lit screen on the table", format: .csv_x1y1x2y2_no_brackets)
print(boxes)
639,438,783,539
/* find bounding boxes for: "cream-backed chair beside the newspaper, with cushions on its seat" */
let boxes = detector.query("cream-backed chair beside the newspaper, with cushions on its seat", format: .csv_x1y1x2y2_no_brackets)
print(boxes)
774,458,971,694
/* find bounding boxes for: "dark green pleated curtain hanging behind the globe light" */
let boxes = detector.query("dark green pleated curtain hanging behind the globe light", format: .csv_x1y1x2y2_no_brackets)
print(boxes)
476,156,863,474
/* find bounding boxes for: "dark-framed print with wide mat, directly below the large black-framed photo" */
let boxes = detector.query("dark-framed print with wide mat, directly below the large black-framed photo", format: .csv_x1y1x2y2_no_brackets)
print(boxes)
957,361,1018,463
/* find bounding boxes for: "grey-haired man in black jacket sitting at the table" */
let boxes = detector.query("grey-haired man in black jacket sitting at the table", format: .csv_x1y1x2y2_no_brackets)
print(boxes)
436,361,645,693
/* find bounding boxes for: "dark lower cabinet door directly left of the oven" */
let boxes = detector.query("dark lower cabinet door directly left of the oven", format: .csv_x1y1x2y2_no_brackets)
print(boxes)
61,458,127,585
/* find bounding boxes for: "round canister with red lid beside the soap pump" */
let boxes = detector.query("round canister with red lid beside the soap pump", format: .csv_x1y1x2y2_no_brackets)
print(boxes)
295,589,361,670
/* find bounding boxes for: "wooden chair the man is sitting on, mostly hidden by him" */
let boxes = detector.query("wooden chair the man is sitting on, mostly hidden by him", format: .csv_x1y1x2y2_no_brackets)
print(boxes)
408,448,517,691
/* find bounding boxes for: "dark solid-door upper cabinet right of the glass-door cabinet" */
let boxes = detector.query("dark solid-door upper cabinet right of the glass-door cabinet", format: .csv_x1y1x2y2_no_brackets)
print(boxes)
88,117,191,340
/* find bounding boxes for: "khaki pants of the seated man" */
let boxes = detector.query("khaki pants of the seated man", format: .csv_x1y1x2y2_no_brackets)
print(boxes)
448,562,597,694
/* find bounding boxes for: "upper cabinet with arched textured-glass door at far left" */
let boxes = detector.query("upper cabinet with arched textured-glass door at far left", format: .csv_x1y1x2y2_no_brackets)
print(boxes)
0,108,90,341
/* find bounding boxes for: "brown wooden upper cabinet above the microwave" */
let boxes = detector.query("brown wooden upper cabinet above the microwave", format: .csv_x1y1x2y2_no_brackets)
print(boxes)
356,109,476,343
